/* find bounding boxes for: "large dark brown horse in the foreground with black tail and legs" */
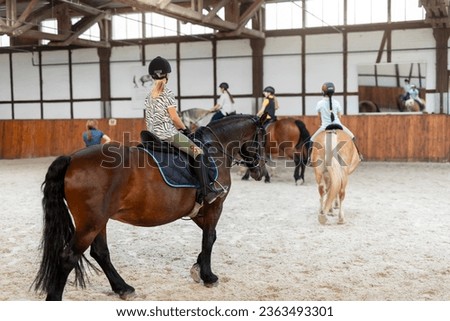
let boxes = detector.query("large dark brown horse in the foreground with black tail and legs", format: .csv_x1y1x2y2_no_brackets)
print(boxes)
34,115,266,300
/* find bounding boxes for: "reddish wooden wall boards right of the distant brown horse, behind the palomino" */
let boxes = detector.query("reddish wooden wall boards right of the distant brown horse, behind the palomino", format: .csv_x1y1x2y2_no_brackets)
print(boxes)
299,114,450,162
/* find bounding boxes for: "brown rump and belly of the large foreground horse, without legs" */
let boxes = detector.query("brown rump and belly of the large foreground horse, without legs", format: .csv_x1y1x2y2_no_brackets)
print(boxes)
65,146,195,228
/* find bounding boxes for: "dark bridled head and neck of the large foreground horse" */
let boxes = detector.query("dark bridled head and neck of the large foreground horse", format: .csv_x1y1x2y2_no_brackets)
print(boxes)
204,115,266,181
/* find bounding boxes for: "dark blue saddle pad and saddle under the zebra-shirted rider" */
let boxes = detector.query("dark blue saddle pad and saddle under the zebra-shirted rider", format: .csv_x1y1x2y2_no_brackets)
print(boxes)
138,131,219,188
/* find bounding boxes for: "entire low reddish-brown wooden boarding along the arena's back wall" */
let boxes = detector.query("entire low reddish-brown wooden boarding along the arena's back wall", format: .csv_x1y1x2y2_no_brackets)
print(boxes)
0,114,450,162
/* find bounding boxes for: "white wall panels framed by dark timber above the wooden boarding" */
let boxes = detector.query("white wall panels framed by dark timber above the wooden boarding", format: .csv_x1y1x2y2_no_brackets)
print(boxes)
0,29,447,119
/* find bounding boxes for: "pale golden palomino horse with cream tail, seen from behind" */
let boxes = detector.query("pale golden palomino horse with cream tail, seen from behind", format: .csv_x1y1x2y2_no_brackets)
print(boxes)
311,129,361,224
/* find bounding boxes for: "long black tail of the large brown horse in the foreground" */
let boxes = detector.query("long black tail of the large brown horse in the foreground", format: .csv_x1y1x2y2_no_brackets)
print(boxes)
33,156,89,293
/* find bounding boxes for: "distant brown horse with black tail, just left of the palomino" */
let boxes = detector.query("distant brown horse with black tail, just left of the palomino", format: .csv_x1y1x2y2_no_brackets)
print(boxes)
242,118,310,184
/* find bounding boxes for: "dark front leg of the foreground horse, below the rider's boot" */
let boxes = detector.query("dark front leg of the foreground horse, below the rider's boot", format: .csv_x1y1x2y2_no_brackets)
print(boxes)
191,208,222,287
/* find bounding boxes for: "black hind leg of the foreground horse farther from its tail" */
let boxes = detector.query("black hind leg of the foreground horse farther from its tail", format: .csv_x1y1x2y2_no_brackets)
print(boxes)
91,227,134,299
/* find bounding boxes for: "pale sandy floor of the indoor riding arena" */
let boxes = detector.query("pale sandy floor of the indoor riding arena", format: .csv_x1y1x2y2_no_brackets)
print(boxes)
0,158,450,301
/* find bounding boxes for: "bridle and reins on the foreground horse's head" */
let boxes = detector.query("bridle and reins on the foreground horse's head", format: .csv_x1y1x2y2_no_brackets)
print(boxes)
205,117,265,169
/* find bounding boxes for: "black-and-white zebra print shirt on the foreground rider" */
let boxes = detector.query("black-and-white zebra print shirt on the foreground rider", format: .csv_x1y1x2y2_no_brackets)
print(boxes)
144,87,178,140
